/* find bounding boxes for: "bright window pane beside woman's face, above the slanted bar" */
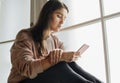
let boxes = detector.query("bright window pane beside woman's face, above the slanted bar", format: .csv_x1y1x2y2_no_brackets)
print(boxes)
63,0,100,26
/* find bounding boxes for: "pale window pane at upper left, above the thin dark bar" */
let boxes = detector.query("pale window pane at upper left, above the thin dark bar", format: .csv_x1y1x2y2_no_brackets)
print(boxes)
0,0,30,42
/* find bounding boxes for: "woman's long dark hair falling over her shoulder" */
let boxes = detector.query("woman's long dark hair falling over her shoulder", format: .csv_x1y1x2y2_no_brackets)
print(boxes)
31,0,69,51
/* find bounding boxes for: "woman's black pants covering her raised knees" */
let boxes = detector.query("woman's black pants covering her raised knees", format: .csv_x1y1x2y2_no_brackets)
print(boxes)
20,62,102,83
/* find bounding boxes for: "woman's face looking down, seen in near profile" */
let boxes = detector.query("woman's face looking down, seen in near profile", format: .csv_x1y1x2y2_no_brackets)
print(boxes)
50,8,68,32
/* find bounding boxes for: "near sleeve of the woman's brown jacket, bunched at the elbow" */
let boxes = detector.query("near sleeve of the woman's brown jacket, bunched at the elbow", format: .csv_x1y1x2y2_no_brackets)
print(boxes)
11,32,43,78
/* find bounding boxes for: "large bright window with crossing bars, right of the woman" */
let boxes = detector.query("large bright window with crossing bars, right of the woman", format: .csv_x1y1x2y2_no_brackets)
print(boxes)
57,0,120,83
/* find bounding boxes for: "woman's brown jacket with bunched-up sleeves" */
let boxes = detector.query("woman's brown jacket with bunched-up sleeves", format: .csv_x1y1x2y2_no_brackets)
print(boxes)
8,30,63,83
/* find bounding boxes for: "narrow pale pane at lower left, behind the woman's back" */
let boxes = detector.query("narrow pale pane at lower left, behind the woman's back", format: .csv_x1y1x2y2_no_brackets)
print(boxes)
0,43,12,83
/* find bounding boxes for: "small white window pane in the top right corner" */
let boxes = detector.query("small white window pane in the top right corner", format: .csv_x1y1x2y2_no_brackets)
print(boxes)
103,0,120,15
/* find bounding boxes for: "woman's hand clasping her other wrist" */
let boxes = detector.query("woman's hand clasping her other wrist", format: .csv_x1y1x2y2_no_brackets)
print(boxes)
49,49,63,64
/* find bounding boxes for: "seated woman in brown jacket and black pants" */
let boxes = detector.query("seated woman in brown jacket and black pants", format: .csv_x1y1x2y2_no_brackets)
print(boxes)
8,0,101,83
